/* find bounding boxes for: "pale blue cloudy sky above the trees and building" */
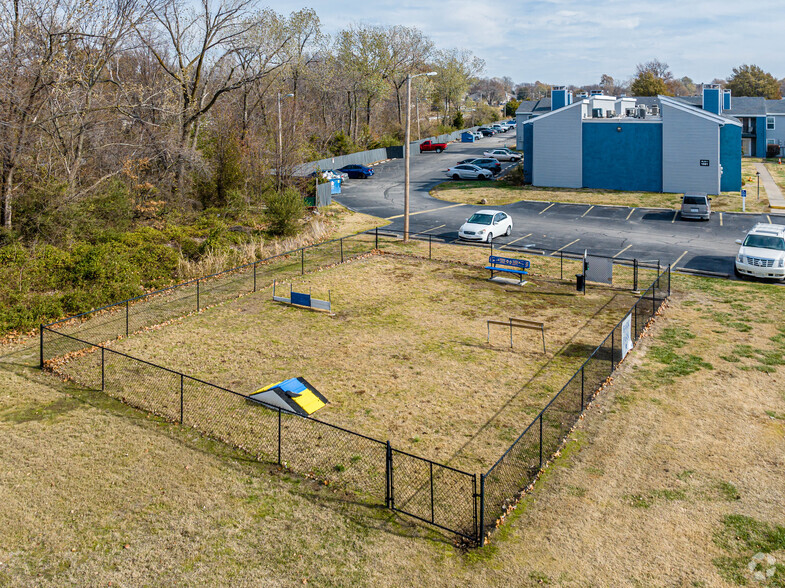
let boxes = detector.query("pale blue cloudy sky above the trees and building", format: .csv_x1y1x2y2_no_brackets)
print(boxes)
271,0,785,85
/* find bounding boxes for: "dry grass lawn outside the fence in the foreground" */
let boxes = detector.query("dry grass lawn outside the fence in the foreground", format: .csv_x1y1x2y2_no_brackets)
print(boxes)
0,259,785,587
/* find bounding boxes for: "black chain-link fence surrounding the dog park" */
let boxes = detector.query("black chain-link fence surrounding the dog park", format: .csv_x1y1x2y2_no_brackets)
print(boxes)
40,224,670,543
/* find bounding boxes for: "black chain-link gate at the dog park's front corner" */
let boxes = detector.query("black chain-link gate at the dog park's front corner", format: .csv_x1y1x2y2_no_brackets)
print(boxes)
387,449,479,541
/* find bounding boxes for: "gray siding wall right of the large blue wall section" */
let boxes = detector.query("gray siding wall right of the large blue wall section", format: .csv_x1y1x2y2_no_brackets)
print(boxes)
662,104,720,194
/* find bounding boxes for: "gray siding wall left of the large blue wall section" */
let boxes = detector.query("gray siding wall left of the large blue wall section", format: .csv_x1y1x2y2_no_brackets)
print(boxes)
524,105,583,188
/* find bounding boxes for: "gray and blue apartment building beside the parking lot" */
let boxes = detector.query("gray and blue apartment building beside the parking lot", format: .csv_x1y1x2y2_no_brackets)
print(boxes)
516,86,744,194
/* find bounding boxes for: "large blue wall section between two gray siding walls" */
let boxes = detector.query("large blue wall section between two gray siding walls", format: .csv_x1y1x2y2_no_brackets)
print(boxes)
583,122,662,192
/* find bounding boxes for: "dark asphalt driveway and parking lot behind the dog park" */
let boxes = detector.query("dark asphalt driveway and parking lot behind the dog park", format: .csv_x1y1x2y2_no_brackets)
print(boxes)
336,131,785,276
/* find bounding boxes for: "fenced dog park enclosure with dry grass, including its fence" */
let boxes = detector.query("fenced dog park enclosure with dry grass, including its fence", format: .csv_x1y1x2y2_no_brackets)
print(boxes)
42,234,662,540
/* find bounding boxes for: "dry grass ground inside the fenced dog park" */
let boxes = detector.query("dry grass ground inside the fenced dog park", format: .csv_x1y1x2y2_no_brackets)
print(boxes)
73,253,635,471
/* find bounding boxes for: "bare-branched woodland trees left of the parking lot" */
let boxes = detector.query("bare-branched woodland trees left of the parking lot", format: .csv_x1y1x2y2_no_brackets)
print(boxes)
0,0,487,244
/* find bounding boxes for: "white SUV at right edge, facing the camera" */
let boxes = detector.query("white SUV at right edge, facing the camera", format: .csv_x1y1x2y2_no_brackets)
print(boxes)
735,223,785,280
